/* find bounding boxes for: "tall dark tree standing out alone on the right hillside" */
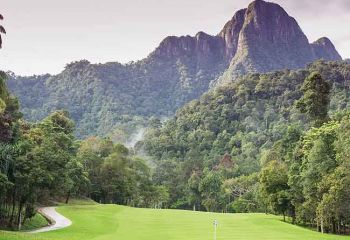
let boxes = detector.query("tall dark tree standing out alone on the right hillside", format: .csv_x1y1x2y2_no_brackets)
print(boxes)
296,72,331,126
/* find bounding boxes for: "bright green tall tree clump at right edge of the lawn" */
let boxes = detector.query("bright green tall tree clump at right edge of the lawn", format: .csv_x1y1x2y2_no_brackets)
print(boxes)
287,119,344,233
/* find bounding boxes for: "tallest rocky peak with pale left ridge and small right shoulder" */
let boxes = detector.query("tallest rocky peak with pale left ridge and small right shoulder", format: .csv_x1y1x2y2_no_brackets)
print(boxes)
219,0,342,82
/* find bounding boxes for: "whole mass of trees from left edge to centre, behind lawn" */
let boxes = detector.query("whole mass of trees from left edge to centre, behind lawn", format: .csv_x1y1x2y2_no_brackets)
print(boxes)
0,68,160,228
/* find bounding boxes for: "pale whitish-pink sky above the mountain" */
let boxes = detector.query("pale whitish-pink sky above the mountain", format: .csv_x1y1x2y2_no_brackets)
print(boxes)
0,0,350,75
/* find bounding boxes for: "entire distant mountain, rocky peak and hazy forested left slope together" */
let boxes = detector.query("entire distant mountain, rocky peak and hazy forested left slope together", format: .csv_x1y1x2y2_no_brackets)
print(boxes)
8,0,341,137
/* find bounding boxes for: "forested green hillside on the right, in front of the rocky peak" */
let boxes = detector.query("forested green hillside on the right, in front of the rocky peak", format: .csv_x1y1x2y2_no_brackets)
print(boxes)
139,61,350,221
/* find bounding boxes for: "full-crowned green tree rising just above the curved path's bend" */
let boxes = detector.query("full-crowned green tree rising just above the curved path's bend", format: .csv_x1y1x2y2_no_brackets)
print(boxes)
32,111,75,195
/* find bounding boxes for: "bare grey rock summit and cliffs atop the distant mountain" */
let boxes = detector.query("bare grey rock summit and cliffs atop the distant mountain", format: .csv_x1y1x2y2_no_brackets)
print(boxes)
151,0,342,81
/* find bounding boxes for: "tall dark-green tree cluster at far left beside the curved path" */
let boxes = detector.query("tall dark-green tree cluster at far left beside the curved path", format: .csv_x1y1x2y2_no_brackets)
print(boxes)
0,72,85,228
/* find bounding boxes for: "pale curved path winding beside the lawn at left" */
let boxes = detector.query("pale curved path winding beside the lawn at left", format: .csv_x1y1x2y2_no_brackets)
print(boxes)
31,207,72,233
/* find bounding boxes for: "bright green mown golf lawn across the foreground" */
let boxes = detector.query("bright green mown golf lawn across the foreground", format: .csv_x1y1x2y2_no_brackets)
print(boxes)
0,205,350,240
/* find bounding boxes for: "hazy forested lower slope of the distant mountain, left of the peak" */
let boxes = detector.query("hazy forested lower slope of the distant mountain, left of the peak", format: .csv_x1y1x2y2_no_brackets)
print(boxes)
9,48,226,139
